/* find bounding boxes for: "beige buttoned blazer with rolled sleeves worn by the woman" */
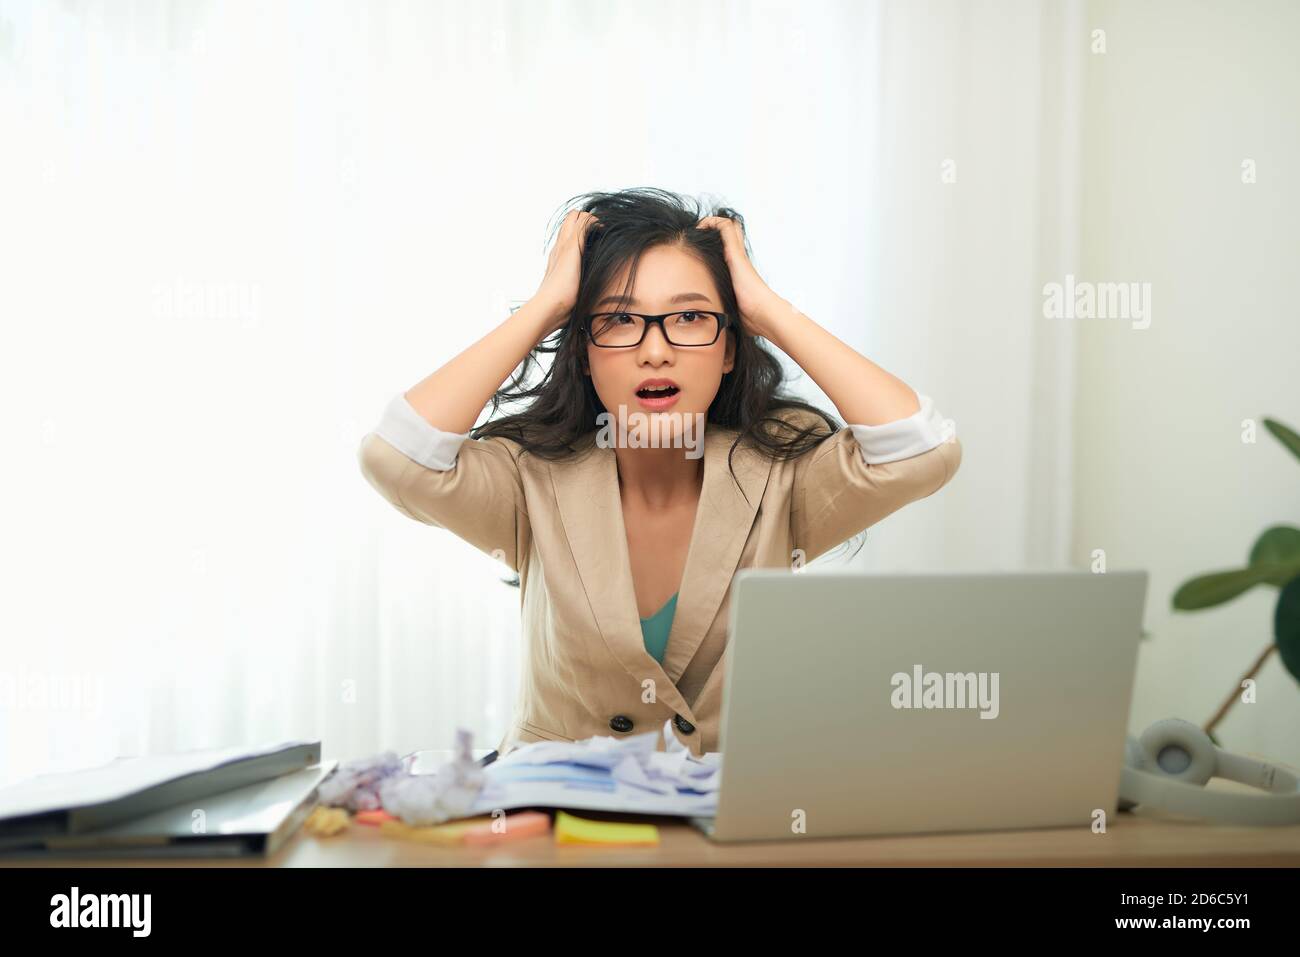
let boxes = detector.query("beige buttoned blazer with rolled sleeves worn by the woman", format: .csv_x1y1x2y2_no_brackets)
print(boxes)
359,403,962,755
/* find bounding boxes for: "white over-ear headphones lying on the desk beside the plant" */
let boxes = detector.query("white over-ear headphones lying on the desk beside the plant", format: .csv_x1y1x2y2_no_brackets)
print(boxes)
1119,718,1300,824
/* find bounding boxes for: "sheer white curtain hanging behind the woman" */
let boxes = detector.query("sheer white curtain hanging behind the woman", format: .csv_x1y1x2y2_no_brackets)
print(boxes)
0,0,1086,783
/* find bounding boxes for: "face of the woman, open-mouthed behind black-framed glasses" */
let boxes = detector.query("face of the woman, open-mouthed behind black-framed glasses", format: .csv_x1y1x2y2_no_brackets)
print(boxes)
586,246,736,432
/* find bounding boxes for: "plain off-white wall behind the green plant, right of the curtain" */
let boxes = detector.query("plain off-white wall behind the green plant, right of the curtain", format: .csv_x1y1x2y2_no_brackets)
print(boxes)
1076,0,1300,765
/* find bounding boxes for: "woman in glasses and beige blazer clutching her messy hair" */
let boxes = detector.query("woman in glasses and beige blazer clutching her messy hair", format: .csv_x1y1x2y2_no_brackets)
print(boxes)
360,189,961,755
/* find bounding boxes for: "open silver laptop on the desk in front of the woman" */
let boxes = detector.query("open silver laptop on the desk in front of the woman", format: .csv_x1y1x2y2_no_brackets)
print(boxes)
693,568,1148,841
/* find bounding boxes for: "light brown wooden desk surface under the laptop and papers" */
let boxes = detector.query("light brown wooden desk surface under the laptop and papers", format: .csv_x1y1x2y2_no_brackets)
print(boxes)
4,810,1300,867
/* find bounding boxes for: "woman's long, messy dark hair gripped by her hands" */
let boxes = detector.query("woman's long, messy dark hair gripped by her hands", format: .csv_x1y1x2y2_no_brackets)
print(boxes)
471,187,855,564
